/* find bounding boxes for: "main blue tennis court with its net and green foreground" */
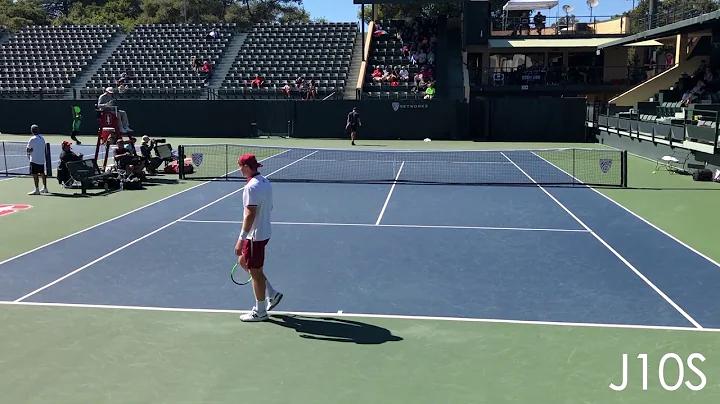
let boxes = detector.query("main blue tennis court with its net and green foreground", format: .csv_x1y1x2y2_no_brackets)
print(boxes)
0,145,720,403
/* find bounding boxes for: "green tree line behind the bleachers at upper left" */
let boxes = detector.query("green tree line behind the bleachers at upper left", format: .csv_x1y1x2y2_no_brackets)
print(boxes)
0,0,310,31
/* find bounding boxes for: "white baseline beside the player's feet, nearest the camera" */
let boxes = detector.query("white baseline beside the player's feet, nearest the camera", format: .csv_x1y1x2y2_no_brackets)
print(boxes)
0,301,720,333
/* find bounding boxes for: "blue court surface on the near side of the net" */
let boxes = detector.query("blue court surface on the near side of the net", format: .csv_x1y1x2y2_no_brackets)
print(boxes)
0,150,720,328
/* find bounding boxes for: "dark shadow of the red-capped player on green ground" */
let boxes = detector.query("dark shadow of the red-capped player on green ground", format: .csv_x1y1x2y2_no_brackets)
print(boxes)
268,314,403,345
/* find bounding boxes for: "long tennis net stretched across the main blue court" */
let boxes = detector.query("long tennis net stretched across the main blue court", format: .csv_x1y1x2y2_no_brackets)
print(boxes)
179,144,627,187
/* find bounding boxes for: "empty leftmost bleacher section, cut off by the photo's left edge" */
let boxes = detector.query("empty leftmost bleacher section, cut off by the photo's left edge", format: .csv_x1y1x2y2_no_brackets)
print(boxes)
0,25,119,98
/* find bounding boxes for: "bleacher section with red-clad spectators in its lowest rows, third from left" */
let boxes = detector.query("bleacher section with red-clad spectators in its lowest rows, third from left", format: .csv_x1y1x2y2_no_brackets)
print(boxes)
218,23,358,99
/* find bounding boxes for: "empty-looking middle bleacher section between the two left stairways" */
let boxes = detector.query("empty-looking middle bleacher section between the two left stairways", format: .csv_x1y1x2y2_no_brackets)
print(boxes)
81,23,236,98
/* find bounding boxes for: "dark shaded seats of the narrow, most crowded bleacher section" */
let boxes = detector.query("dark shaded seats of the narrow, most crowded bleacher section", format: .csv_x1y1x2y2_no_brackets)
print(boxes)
363,20,436,99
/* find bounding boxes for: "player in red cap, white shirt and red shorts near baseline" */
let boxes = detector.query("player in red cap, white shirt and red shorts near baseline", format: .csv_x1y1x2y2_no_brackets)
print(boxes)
235,154,283,322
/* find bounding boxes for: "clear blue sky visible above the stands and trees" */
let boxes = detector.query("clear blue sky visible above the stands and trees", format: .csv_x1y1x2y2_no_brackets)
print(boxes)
303,0,633,22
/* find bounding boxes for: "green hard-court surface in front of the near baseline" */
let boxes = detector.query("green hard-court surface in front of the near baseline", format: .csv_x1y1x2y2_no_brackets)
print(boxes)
0,306,720,404
